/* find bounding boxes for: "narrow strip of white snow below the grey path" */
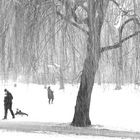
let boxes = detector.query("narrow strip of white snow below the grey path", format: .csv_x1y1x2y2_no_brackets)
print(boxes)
0,131,131,140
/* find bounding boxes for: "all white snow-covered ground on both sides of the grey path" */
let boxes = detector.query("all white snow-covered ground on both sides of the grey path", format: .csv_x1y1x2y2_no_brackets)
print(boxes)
0,83,140,140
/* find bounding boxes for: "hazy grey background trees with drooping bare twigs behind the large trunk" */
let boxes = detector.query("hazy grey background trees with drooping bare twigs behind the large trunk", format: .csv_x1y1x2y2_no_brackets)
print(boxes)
0,0,140,88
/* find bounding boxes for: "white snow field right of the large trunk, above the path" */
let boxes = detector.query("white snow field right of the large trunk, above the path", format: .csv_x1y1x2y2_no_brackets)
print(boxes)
90,85,140,132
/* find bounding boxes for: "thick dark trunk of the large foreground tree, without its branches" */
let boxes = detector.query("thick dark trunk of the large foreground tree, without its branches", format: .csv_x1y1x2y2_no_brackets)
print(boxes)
72,0,108,127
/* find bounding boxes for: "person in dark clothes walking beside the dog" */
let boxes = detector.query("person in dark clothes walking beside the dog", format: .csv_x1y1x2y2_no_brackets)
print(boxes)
3,89,15,119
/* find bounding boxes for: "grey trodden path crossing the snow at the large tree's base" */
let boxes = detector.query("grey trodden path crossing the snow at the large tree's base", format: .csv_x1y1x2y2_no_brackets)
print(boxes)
0,121,140,139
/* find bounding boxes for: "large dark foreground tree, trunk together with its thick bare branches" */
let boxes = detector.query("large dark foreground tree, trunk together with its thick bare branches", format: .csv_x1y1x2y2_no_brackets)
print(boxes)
57,0,140,126
